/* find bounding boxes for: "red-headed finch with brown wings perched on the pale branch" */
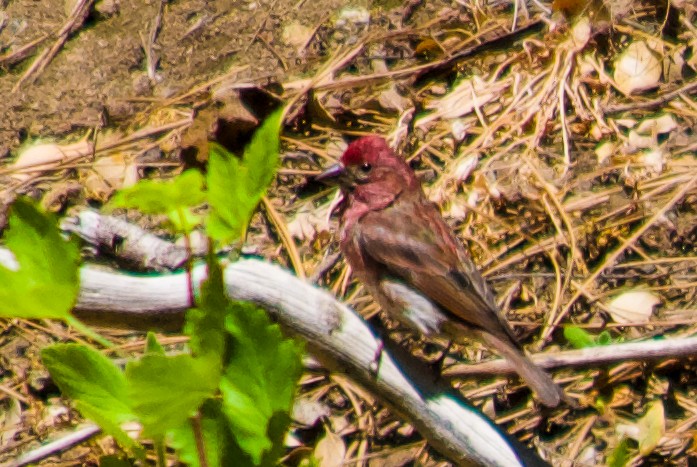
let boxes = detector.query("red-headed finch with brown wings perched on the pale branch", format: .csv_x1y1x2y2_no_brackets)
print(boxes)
316,135,565,407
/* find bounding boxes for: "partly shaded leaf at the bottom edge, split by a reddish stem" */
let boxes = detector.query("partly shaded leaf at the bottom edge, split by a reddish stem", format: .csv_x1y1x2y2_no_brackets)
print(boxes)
169,399,255,467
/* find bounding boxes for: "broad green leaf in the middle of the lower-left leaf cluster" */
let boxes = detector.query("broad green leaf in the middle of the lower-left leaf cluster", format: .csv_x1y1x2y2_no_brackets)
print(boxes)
126,354,220,436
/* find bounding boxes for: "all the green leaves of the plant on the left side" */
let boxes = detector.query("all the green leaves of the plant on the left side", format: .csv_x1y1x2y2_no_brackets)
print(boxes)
25,112,302,467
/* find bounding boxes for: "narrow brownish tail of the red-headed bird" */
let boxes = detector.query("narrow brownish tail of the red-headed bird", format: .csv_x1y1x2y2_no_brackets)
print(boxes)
478,330,567,407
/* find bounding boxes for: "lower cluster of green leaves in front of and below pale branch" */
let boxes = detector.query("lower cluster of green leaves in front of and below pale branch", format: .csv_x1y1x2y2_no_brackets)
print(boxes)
42,264,302,466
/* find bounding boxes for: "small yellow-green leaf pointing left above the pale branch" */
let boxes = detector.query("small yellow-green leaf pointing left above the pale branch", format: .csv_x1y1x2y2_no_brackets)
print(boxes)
107,169,206,231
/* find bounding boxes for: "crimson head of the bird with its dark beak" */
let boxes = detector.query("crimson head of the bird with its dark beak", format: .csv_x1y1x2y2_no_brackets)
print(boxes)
316,136,419,191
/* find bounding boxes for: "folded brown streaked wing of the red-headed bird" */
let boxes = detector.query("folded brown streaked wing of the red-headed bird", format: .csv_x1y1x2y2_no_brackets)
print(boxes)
353,200,515,342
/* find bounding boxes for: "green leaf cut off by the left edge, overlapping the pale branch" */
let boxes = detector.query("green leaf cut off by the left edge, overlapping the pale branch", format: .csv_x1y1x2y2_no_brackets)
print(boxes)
0,198,80,320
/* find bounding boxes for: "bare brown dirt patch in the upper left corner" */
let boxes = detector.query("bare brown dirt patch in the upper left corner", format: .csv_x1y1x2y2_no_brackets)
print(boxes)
0,0,343,156
